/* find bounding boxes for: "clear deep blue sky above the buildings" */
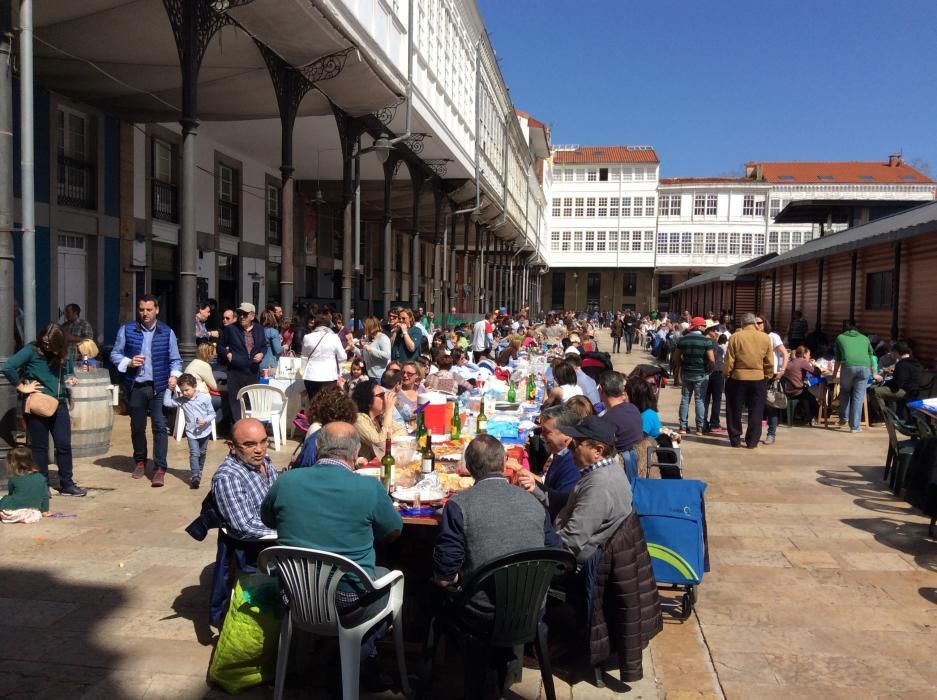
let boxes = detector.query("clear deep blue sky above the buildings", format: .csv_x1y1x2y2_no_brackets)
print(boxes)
478,0,937,178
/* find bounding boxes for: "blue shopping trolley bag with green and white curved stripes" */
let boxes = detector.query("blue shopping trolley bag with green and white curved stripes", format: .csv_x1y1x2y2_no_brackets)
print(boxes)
633,479,708,586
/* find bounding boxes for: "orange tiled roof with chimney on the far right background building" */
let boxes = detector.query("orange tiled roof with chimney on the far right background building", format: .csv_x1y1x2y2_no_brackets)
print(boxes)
746,161,934,184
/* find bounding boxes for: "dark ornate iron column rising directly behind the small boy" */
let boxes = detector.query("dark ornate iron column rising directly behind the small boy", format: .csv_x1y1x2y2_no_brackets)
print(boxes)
163,0,233,359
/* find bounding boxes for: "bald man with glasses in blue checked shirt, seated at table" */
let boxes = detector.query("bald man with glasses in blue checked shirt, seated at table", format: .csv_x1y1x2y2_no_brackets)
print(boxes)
211,418,277,539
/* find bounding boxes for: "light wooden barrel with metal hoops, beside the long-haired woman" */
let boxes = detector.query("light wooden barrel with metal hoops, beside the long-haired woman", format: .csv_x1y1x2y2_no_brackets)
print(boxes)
70,369,114,457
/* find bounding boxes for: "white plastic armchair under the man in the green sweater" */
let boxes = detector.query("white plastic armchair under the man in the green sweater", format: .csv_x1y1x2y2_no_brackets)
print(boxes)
257,547,410,700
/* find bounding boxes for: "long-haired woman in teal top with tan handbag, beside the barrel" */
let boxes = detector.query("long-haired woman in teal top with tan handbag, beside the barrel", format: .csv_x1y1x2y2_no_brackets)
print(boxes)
3,323,87,496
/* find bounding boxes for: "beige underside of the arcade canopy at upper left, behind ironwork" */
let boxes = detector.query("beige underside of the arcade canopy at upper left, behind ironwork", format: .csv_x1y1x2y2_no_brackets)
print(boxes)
34,0,405,122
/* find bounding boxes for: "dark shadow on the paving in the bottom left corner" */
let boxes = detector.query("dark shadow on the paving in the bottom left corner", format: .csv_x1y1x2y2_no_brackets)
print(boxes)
0,568,133,700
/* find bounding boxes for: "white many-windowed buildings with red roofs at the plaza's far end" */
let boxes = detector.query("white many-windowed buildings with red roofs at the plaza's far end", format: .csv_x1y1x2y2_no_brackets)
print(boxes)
542,152,937,310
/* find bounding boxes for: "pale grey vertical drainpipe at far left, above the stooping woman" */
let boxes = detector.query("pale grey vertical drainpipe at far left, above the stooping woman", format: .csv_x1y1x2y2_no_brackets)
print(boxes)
20,0,36,343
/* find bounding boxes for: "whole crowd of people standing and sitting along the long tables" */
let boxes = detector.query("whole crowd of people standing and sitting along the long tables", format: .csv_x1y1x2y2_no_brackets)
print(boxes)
0,295,922,696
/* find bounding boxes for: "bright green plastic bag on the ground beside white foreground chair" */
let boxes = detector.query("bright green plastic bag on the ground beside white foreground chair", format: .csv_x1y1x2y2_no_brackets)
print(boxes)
208,574,284,694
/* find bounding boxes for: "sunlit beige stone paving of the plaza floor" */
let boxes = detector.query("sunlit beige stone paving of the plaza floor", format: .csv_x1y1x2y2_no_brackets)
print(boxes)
0,335,937,700
